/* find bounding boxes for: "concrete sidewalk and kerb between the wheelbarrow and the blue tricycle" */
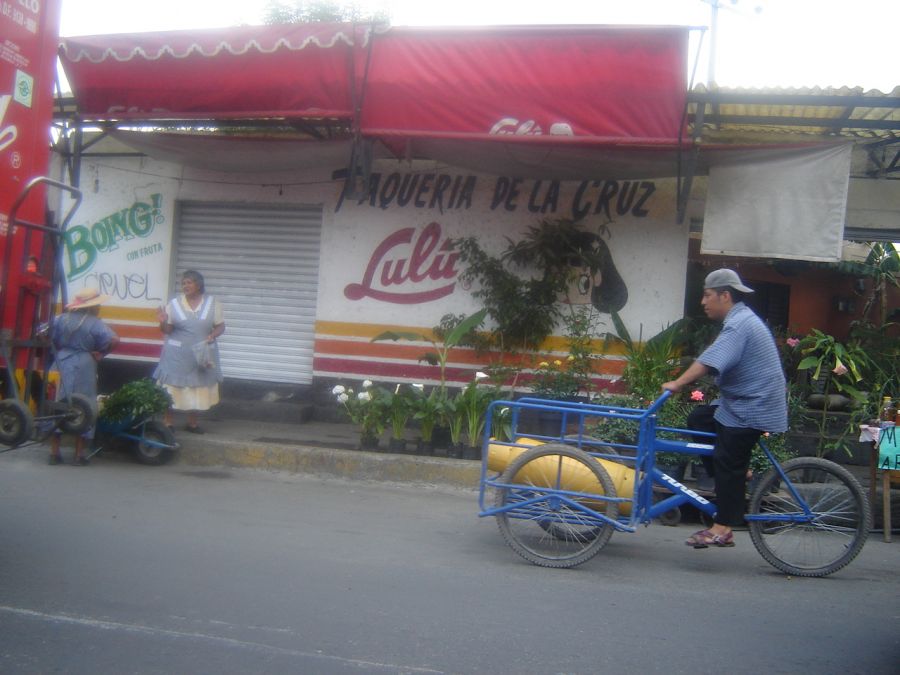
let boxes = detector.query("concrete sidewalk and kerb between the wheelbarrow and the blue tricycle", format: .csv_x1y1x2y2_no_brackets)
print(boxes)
165,414,481,490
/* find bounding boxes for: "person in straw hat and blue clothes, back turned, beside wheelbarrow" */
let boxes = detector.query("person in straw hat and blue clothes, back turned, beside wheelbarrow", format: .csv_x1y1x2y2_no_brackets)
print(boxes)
49,288,119,466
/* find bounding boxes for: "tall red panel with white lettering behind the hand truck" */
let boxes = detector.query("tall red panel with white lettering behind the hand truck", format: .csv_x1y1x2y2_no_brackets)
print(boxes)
0,0,61,336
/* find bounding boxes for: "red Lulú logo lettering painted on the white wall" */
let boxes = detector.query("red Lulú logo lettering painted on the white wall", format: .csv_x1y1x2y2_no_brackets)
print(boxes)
344,222,459,305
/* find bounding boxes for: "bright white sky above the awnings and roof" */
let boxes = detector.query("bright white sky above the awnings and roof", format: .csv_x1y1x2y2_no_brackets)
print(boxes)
60,0,900,93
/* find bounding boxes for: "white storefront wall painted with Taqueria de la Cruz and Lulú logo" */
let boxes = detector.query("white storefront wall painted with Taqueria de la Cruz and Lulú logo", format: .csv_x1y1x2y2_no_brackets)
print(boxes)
314,171,687,390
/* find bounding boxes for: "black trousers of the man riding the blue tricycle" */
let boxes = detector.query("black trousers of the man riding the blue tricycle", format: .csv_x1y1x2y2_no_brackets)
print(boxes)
687,405,763,527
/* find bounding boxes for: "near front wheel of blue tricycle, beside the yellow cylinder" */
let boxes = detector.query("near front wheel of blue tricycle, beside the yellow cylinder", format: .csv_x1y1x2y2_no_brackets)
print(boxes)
494,444,618,567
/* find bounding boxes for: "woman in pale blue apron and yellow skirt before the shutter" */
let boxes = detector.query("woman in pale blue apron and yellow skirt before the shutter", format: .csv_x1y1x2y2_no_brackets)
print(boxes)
153,270,225,434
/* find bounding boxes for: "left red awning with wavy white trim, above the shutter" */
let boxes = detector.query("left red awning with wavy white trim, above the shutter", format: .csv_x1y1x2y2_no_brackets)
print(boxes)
60,24,366,119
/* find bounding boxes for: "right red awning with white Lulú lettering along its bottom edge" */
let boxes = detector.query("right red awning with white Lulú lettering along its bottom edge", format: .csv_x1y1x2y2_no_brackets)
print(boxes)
360,26,688,144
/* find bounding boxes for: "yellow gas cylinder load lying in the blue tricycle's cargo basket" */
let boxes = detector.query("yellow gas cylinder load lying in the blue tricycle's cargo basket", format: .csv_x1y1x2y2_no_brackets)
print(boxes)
487,438,634,515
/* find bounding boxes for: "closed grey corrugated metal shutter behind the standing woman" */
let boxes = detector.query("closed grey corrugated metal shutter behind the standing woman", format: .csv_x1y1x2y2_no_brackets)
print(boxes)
175,202,322,384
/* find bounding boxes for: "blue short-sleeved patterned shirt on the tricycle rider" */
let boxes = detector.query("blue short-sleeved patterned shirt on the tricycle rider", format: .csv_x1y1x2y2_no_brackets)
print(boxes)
698,302,787,433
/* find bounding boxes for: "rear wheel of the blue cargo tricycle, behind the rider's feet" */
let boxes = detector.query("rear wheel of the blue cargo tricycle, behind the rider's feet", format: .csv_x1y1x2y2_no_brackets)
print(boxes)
749,457,871,577
